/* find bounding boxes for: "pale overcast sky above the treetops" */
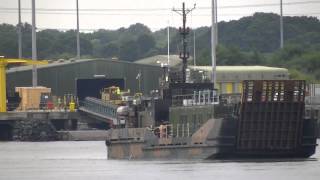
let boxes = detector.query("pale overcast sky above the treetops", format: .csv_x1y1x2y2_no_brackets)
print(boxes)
0,0,320,31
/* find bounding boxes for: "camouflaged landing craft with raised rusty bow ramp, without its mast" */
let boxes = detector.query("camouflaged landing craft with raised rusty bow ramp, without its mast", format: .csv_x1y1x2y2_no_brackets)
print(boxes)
106,80,317,159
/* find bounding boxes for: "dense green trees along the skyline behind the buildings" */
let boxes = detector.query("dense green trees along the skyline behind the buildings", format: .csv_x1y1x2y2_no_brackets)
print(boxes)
0,13,320,81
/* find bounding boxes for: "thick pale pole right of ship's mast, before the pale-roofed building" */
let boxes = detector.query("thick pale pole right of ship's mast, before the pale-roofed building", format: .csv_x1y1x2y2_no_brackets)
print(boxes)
211,0,216,86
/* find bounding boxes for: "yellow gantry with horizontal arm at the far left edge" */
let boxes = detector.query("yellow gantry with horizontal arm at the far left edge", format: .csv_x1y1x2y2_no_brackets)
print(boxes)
0,56,48,112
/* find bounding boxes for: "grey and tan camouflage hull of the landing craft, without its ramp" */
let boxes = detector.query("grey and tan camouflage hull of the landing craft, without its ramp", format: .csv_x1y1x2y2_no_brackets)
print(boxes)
106,119,316,160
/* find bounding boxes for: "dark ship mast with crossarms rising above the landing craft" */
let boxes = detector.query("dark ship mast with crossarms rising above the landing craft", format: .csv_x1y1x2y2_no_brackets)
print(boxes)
173,3,196,83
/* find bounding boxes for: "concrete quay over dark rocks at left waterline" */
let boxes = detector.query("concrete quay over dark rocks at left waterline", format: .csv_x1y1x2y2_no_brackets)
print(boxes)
0,111,80,141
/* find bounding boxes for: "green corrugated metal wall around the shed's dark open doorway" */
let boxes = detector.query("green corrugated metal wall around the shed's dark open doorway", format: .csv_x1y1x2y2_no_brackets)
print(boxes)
7,59,162,96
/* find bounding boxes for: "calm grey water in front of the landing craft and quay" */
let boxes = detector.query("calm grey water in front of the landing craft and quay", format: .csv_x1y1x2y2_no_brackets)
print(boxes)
0,142,320,180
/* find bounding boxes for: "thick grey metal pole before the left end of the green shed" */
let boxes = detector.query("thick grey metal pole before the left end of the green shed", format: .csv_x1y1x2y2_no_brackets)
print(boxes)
32,0,38,87
